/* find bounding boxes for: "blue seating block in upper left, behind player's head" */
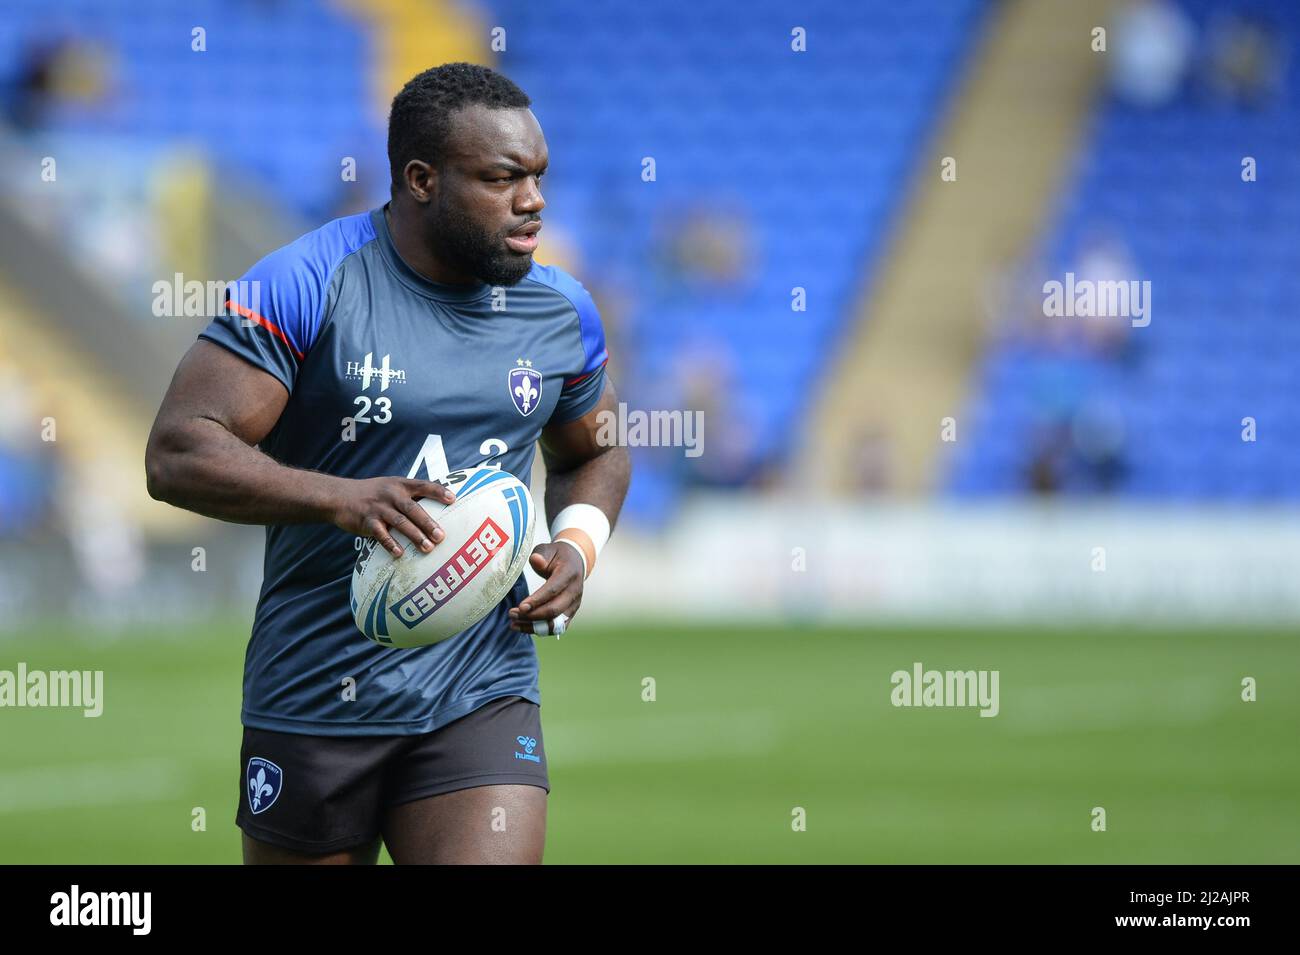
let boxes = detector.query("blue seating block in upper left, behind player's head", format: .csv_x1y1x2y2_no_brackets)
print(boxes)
0,0,387,218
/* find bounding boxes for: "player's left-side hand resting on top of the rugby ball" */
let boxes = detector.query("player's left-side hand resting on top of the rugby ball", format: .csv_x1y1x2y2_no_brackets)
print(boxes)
334,477,456,557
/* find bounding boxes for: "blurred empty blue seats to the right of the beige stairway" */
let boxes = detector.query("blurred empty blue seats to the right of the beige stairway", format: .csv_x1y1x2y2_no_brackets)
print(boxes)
946,0,1300,500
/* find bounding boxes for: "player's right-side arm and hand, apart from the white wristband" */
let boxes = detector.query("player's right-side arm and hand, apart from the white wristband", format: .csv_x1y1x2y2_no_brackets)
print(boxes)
510,379,632,633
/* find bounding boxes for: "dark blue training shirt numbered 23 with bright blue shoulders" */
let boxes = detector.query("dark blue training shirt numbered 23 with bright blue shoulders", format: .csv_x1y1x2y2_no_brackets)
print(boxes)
200,209,606,735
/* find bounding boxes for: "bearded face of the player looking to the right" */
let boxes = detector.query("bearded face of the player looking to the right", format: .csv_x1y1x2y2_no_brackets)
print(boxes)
410,105,549,286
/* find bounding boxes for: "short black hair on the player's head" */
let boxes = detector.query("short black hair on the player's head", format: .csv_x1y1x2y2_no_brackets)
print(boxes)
389,62,533,194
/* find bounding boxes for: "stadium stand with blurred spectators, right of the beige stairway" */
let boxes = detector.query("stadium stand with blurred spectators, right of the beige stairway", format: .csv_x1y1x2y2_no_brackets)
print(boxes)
946,0,1300,500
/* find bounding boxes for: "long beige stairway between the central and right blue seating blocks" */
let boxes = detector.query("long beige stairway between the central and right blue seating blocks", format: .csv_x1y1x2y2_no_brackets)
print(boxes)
802,0,1115,494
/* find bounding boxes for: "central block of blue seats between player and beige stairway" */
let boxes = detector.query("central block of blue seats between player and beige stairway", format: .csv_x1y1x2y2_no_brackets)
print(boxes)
489,0,984,520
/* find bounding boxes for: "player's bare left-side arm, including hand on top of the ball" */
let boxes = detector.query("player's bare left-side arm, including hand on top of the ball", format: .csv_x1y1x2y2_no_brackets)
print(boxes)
144,340,451,555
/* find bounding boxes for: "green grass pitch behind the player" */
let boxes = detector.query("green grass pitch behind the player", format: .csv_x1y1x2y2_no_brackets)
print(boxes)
0,618,1300,863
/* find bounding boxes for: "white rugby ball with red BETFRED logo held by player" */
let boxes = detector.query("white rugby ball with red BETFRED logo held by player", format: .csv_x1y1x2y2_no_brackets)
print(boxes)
351,468,534,647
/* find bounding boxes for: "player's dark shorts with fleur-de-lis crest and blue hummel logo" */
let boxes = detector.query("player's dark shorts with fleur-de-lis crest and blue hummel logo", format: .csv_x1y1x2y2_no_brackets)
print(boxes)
235,696,551,855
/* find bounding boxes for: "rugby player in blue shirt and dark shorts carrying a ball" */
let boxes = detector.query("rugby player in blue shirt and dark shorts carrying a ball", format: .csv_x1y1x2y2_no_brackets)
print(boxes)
146,64,629,863
